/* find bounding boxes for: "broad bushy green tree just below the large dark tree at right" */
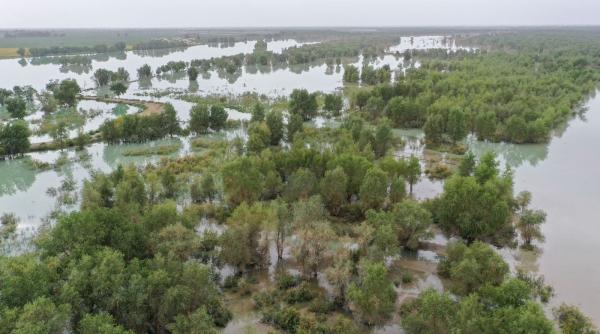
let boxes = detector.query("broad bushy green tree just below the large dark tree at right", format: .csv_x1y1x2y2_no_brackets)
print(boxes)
438,242,509,296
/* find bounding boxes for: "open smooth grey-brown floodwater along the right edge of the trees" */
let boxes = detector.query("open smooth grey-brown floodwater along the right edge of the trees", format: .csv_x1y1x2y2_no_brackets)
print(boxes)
469,95,600,325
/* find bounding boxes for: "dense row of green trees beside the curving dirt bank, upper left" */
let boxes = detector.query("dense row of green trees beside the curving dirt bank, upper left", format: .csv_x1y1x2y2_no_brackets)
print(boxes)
100,103,181,144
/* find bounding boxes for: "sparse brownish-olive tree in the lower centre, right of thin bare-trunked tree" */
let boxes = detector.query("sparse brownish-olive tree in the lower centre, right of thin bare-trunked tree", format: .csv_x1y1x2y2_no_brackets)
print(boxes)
293,221,335,278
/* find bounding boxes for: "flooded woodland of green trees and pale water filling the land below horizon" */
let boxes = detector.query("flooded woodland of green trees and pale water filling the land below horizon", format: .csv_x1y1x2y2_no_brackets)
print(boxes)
0,28,600,333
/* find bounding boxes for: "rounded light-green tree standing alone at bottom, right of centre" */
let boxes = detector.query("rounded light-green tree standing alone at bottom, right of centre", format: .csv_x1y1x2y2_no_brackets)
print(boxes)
348,262,396,325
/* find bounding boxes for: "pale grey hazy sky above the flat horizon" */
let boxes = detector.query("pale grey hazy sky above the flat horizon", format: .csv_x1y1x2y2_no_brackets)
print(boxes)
0,0,600,28
